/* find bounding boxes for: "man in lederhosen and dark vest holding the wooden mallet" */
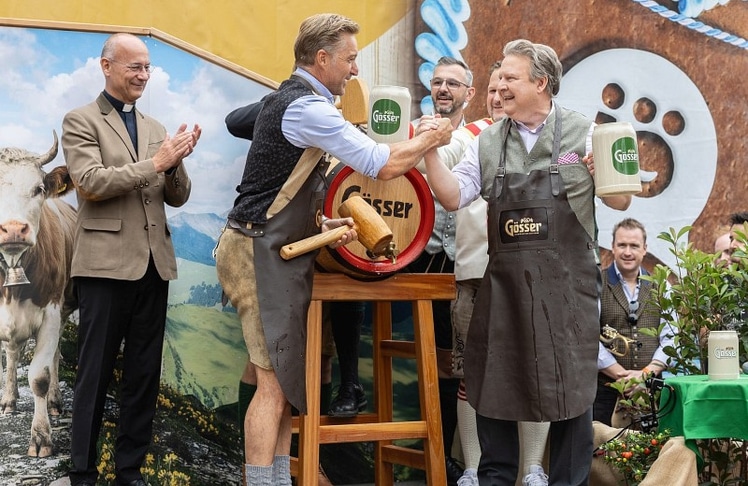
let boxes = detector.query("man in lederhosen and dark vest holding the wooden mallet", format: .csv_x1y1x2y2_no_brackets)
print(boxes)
216,14,452,486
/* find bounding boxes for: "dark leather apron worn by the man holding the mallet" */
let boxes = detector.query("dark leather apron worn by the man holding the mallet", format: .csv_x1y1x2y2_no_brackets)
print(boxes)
251,157,328,413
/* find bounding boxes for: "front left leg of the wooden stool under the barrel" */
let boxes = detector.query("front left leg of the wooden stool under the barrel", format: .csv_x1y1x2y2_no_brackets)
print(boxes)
298,300,322,486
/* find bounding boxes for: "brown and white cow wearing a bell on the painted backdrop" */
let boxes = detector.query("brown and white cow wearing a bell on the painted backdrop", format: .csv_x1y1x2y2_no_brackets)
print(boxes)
0,133,76,457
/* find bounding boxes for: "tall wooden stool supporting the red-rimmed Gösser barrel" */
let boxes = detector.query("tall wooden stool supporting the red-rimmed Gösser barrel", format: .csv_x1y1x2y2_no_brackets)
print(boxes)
291,273,456,486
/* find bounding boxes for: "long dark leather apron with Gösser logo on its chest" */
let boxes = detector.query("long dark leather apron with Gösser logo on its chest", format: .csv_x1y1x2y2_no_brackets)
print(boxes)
465,114,600,421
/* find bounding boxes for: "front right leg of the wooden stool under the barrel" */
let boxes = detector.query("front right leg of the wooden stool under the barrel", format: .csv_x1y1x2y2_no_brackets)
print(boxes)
413,300,447,484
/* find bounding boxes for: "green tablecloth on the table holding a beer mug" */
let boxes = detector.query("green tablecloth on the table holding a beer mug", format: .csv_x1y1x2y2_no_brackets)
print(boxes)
659,375,748,462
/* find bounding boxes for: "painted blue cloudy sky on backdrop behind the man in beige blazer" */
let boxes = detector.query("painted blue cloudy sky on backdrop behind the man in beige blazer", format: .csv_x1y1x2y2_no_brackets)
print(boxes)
0,27,269,214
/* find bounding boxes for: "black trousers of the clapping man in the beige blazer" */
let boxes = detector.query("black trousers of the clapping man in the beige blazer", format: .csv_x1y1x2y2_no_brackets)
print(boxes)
70,262,169,485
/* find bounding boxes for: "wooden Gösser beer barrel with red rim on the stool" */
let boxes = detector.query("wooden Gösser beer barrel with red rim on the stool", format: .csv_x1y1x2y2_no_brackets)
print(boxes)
316,163,434,280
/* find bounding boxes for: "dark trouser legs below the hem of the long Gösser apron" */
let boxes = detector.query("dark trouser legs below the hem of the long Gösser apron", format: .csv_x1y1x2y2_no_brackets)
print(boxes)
476,409,593,486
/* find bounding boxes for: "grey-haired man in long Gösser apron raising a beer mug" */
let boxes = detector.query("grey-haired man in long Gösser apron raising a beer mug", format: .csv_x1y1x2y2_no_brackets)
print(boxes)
425,39,630,486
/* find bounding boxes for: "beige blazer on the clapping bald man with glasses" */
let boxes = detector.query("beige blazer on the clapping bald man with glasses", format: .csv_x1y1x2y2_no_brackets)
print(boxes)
62,94,191,280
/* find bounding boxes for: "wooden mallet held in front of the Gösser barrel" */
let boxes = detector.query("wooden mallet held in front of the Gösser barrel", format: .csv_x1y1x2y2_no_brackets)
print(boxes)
280,196,392,260
